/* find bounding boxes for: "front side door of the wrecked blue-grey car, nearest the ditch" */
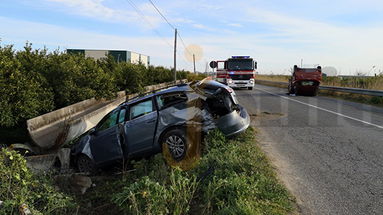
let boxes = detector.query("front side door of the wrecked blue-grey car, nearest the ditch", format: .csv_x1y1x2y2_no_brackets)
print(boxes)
90,109,123,165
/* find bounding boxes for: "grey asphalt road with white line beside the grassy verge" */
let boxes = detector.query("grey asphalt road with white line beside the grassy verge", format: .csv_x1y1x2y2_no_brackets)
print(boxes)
236,85,383,214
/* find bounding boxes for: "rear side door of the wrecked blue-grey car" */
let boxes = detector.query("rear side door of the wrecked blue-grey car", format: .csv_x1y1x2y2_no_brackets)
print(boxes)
125,98,157,156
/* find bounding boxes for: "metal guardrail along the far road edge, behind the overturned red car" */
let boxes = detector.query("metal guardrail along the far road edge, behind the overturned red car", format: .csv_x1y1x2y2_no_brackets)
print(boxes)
255,80,383,96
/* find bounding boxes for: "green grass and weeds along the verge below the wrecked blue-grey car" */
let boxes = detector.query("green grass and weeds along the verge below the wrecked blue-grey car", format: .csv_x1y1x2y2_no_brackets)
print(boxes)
0,128,295,215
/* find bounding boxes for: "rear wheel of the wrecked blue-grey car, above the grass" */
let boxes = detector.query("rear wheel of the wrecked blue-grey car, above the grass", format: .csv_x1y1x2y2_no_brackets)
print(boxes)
162,129,188,162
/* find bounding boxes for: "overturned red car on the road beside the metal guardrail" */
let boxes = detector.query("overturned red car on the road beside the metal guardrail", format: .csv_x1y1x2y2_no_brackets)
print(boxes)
288,65,322,96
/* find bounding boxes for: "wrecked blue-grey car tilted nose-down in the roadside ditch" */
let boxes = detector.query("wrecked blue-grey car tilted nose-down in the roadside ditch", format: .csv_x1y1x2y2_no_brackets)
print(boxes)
71,80,250,172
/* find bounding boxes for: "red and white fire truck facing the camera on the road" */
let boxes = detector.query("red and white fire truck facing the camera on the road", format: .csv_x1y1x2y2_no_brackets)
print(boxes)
210,56,257,90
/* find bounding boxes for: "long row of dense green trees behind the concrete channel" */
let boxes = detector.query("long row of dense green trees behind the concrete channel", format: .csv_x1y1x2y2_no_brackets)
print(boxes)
0,43,206,128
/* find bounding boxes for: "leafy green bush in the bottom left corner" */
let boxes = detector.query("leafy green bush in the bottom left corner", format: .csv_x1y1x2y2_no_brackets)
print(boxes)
0,149,75,214
